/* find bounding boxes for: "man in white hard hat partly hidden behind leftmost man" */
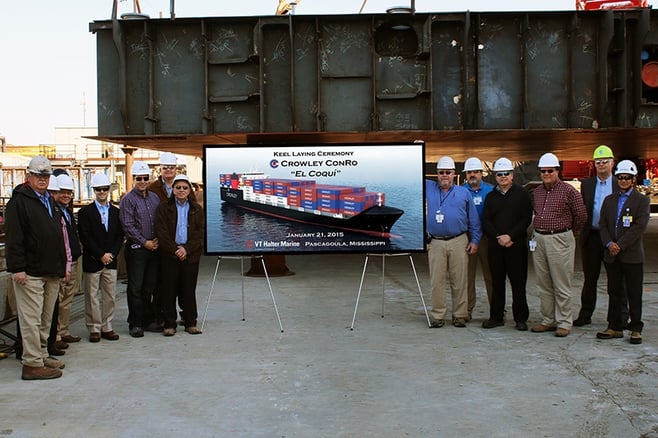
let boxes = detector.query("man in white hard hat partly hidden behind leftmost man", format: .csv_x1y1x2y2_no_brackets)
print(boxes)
53,173,82,350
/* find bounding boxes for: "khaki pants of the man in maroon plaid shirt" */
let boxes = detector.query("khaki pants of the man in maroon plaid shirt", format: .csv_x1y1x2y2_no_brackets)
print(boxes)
531,231,576,330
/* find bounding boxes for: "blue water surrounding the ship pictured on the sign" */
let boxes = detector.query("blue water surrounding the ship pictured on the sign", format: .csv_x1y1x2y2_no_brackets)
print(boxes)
205,179,424,253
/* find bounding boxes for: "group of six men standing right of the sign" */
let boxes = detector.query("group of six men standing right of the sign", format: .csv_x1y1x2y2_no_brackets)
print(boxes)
425,145,650,344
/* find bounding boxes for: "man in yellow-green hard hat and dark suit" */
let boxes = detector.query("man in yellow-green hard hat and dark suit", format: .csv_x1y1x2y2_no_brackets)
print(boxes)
573,145,628,327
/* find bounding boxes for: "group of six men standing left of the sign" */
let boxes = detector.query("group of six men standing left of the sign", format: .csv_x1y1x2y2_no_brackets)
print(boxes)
5,152,205,380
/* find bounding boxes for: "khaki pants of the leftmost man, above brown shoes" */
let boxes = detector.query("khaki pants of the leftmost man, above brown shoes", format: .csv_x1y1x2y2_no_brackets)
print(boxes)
14,275,60,367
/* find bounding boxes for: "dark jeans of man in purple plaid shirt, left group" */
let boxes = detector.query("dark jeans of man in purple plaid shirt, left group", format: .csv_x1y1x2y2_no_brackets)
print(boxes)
125,243,158,328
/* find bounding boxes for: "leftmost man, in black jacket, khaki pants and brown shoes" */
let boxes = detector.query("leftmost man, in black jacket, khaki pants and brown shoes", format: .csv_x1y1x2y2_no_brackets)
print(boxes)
5,155,67,380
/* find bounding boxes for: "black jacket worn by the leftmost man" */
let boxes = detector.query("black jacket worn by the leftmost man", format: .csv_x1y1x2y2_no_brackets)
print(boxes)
5,185,66,277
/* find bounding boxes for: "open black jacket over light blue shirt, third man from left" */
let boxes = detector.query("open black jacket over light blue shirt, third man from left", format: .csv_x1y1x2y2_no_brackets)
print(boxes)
78,202,123,272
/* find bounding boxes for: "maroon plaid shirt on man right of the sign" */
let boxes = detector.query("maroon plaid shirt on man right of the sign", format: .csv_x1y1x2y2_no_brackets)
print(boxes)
532,179,587,231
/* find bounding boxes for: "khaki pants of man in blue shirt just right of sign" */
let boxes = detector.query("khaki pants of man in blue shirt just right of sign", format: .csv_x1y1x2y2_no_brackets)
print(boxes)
427,233,468,320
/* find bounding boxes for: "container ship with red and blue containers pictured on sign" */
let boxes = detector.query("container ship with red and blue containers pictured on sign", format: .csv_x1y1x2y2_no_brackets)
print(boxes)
219,172,404,237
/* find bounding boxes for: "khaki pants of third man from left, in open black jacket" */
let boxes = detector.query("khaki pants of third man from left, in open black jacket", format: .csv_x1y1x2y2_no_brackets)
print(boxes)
84,268,117,333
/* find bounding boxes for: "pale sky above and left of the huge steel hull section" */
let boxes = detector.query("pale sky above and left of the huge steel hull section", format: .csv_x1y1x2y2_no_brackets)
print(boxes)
0,0,575,145
